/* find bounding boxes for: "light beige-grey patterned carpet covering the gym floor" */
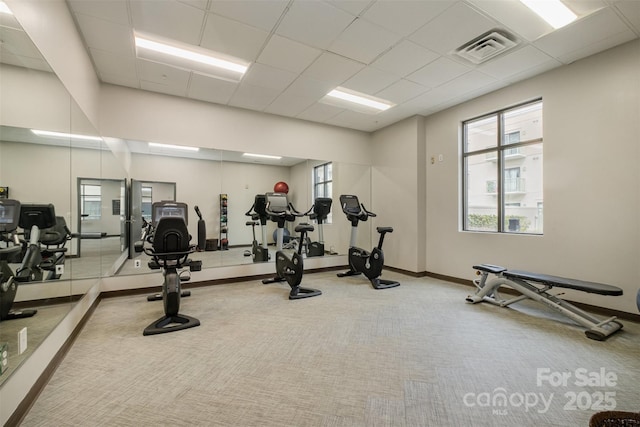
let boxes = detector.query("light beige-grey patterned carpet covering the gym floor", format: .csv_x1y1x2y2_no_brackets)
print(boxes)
17,272,640,427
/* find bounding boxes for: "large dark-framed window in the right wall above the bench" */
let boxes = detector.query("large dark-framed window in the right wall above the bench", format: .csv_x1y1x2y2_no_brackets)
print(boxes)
462,100,543,234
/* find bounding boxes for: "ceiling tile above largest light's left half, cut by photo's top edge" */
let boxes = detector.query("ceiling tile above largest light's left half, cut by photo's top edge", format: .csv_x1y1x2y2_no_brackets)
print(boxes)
129,0,206,46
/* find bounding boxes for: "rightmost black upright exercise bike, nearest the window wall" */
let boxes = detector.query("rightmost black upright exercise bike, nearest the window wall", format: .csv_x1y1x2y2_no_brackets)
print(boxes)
338,195,400,289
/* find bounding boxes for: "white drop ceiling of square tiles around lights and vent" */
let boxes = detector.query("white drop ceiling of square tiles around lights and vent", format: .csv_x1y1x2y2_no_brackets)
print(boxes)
13,0,640,131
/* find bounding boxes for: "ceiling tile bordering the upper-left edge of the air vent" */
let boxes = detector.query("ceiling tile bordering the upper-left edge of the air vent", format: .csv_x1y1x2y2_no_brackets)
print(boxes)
409,2,497,54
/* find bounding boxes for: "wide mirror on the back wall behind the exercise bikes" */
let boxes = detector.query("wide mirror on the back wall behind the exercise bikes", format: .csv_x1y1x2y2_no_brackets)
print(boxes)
102,137,371,276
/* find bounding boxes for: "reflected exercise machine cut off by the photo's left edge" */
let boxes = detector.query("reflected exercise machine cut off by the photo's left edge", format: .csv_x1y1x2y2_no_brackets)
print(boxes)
0,199,37,321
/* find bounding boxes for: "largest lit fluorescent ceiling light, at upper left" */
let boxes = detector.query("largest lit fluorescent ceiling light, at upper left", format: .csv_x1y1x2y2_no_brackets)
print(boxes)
134,33,249,81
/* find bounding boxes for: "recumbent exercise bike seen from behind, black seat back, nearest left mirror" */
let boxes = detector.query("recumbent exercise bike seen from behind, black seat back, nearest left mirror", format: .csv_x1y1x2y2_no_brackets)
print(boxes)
135,202,202,335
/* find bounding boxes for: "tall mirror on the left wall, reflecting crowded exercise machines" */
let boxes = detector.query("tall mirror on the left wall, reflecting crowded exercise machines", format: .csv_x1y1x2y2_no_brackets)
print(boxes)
0,14,112,387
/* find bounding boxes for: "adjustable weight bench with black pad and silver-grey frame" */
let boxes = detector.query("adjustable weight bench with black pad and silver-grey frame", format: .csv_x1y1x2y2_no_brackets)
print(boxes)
467,264,622,341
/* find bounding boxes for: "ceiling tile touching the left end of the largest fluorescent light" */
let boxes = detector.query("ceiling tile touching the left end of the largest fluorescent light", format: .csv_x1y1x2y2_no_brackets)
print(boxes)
76,14,135,55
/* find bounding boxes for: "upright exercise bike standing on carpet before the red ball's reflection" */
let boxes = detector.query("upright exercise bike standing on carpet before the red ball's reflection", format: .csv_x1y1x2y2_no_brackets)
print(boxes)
262,193,322,300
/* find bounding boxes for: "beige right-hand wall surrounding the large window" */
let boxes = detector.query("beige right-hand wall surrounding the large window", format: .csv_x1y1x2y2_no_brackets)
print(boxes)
423,41,640,312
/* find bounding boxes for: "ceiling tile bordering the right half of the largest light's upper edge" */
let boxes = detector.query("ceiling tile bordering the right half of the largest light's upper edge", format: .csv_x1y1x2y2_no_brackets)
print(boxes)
200,13,269,61
